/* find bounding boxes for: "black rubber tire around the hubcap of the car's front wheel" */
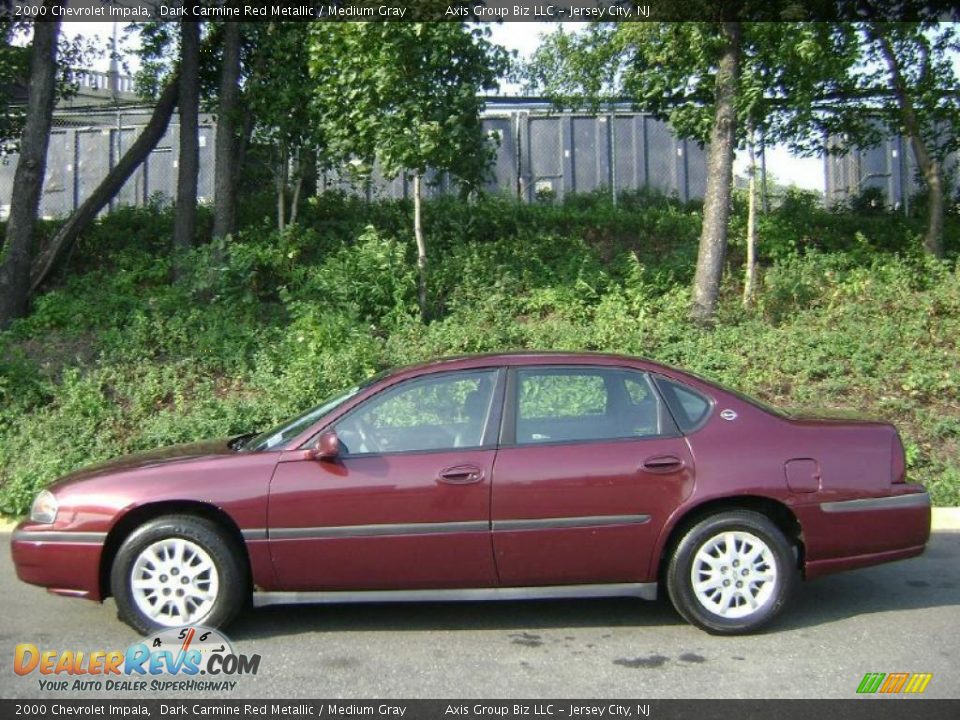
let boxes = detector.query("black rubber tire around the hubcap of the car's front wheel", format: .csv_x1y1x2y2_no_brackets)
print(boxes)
110,515,250,635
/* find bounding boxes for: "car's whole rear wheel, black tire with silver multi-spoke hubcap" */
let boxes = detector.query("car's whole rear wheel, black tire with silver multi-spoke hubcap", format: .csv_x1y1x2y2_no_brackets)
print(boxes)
666,510,799,635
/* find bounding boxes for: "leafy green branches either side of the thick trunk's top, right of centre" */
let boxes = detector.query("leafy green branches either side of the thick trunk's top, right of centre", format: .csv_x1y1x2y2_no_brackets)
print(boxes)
527,22,859,150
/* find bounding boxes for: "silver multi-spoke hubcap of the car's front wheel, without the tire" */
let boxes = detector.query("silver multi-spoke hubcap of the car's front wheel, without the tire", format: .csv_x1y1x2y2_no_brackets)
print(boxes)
130,538,220,627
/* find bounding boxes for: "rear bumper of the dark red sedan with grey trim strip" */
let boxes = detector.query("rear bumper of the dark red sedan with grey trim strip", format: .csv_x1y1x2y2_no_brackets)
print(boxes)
795,485,930,579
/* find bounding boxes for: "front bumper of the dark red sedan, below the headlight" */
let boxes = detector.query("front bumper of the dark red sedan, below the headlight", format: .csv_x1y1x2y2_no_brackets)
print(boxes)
10,523,106,600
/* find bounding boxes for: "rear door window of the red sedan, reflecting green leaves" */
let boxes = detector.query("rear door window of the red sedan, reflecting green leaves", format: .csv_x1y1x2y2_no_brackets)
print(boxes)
516,368,674,445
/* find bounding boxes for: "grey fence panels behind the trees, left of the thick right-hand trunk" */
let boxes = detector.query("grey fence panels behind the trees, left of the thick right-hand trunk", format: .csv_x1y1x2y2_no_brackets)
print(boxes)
0,105,706,218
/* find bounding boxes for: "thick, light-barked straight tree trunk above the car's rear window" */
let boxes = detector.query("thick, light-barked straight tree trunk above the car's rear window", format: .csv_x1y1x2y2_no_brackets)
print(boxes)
691,22,741,323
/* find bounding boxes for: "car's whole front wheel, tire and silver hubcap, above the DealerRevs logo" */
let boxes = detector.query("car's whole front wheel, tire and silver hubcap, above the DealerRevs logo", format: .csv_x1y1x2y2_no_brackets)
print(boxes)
110,515,249,634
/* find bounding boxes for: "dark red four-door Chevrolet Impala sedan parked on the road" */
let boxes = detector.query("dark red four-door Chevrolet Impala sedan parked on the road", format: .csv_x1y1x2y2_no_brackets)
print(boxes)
12,353,930,634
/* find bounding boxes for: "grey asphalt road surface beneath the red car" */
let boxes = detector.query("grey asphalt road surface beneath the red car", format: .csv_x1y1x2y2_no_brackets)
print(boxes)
0,532,960,699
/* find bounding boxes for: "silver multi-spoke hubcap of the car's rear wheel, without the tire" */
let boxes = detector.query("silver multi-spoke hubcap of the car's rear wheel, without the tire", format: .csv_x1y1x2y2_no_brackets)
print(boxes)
690,530,777,619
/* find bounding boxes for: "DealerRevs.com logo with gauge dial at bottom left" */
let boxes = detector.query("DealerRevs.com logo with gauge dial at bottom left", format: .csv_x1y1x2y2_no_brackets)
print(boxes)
13,626,260,692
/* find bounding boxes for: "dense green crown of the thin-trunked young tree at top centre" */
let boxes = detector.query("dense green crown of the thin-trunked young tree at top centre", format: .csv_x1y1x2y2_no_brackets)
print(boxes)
310,22,507,185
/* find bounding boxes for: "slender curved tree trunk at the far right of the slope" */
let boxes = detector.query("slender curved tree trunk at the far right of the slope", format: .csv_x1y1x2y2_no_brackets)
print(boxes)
869,23,944,258
